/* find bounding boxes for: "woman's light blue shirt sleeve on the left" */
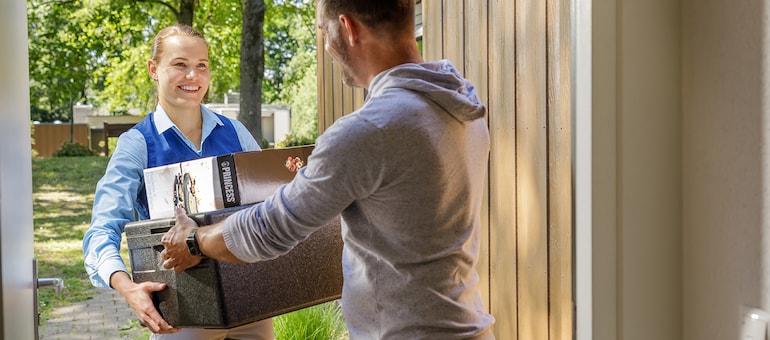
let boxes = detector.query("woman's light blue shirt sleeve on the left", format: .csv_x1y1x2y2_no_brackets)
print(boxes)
83,129,147,288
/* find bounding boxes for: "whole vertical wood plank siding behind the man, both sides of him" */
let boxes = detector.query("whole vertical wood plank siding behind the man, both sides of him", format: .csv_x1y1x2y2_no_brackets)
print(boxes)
318,0,574,340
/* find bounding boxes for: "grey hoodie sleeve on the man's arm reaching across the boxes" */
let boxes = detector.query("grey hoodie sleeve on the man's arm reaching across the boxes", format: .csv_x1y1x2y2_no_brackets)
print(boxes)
223,115,385,262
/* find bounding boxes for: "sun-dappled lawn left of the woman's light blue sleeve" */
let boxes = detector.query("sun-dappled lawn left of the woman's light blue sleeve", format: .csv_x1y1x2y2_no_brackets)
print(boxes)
32,157,108,321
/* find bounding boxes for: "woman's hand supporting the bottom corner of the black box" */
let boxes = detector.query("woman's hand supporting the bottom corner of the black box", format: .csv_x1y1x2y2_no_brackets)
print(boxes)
111,272,182,334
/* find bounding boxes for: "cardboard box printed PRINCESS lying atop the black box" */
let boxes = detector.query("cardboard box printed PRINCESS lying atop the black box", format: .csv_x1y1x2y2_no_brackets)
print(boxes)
144,145,313,219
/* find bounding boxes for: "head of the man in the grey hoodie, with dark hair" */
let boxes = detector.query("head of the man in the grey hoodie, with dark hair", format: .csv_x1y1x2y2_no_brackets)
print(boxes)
316,0,421,87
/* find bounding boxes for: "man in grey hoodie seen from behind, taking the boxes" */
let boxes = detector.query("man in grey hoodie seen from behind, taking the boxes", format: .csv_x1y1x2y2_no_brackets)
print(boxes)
162,0,494,339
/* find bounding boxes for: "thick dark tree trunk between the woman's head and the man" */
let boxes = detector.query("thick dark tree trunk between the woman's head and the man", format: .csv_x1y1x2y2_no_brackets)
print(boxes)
238,0,267,144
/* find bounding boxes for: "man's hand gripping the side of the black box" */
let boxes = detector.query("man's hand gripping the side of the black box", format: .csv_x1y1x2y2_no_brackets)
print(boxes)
160,208,203,273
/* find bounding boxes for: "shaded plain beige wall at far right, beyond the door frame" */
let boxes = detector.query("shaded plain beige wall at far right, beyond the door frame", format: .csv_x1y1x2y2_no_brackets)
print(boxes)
682,0,770,340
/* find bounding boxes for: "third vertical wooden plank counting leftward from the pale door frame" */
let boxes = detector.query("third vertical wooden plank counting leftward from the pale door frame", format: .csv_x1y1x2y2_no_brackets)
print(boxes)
486,1,526,339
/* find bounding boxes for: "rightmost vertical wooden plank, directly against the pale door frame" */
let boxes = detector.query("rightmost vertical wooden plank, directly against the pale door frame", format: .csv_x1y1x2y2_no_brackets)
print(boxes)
546,0,573,339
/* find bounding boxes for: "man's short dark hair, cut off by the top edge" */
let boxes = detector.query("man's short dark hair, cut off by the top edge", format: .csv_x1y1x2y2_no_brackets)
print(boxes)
320,0,415,31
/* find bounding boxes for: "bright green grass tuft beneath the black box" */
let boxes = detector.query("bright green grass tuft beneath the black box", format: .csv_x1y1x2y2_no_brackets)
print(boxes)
273,301,347,340
